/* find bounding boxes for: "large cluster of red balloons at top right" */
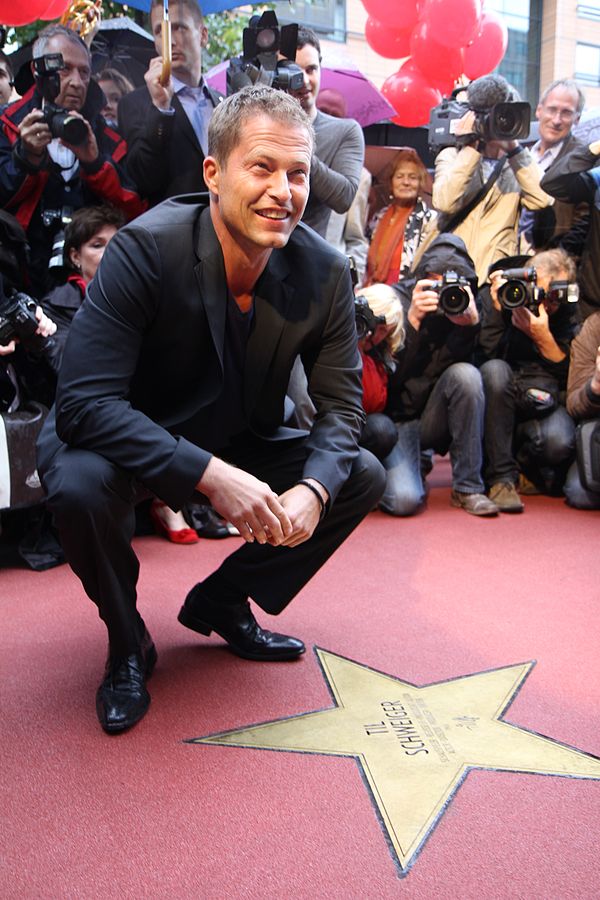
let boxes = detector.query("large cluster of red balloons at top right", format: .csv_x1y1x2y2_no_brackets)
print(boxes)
362,0,508,126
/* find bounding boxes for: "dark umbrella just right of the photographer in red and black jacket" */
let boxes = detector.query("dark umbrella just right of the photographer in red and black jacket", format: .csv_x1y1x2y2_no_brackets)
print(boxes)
91,16,156,86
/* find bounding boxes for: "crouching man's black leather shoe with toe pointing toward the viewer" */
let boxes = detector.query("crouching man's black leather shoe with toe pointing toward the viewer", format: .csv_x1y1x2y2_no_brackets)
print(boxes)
96,631,157,734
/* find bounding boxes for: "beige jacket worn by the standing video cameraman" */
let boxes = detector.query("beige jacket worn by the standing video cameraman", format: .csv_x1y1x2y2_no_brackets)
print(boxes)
419,146,554,284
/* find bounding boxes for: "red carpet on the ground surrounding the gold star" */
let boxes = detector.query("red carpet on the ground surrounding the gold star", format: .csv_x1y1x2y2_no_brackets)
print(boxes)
0,461,600,900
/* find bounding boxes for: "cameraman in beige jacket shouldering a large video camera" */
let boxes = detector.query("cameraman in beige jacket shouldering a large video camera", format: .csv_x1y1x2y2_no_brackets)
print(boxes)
432,75,553,284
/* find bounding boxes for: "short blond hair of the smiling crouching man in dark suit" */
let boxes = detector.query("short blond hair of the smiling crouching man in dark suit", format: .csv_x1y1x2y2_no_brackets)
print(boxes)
208,85,315,166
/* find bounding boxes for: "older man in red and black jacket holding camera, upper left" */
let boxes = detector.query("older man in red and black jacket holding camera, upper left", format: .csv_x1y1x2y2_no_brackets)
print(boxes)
0,25,145,296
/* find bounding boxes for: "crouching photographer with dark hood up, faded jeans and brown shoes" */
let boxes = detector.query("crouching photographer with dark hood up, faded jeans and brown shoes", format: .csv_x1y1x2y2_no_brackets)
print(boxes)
379,234,498,516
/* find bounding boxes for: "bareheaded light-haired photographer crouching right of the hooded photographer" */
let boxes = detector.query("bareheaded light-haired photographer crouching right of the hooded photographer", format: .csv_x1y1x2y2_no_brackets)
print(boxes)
479,249,577,512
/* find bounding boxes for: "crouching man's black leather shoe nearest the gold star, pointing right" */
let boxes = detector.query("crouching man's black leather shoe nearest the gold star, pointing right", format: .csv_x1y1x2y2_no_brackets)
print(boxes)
177,585,306,662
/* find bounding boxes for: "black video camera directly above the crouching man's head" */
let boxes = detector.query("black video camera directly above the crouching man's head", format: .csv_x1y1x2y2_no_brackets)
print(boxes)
227,9,304,96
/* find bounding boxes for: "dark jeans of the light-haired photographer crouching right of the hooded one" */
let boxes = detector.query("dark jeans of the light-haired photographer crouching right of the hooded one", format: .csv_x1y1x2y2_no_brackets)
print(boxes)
480,359,575,494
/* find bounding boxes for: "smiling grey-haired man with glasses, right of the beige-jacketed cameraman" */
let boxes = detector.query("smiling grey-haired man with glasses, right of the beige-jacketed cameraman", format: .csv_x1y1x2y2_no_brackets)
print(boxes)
519,78,588,253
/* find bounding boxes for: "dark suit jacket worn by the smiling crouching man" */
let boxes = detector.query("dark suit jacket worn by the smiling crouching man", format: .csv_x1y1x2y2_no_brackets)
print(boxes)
49,195,364,509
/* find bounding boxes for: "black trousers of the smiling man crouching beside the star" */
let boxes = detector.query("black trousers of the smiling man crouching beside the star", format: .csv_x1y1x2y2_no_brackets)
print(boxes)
38,430,385,654
